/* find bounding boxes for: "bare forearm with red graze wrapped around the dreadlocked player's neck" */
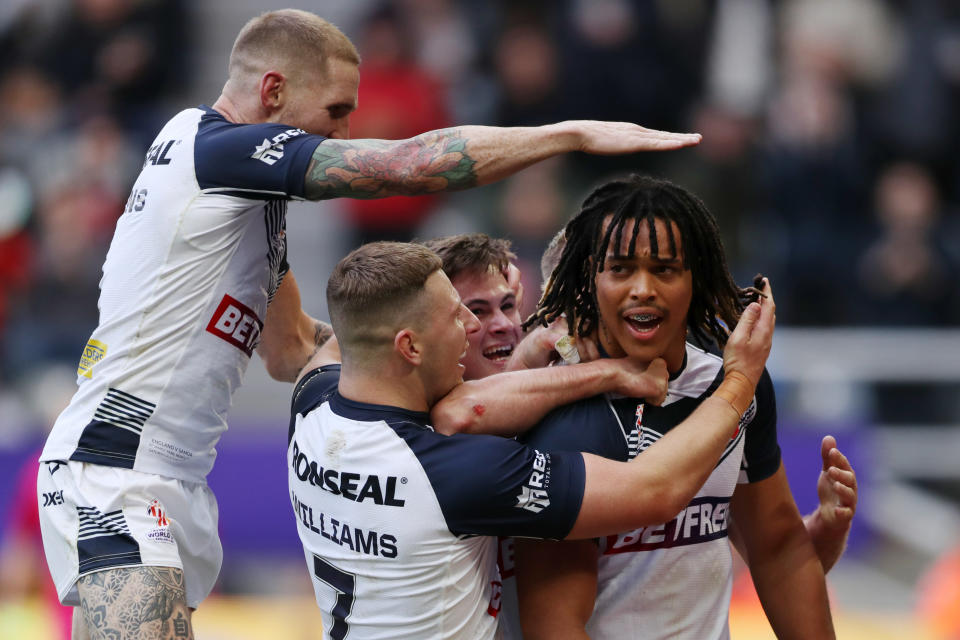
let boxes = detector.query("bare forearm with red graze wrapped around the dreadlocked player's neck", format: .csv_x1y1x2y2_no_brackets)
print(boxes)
431,360,628,436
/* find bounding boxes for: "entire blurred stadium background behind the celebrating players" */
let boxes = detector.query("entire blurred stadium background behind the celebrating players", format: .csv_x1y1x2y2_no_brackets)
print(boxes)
0,0,960,639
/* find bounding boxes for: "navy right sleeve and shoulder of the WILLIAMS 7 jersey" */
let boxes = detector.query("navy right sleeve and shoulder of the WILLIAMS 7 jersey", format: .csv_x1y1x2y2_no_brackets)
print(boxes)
388,421,586,540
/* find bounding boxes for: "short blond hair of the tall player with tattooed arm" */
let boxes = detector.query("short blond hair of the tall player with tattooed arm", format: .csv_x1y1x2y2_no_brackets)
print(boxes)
228,9,360,85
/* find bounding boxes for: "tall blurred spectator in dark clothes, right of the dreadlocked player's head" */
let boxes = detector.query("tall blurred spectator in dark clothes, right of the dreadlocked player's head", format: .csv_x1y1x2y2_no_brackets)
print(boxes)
760,14,865,325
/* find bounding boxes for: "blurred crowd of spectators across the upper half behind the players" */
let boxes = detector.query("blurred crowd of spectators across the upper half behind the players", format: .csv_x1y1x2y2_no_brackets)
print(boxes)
0,0,960,382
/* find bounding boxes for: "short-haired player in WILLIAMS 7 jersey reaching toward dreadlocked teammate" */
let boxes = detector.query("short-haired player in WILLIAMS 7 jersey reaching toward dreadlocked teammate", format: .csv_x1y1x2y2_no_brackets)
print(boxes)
287,243,776,639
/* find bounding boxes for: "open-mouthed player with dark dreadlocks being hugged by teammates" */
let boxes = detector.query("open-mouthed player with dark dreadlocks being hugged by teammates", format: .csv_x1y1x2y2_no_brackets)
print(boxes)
516,176,842,640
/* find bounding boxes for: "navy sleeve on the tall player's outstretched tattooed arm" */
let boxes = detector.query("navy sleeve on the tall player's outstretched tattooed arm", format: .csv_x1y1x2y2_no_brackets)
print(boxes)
194,106,325,200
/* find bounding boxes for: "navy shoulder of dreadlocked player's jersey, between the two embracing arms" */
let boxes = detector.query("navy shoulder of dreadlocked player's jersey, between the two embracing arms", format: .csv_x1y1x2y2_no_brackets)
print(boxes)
521,396,628,461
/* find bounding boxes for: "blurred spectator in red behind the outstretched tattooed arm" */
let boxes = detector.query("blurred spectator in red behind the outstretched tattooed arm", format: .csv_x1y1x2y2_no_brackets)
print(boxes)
343,4,450,247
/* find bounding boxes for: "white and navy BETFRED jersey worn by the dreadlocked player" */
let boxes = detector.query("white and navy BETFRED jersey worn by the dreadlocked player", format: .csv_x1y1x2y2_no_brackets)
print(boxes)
502,343,780,640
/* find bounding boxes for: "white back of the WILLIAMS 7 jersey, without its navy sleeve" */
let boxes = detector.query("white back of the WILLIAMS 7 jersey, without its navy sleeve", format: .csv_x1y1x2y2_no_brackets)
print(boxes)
287,397,499,639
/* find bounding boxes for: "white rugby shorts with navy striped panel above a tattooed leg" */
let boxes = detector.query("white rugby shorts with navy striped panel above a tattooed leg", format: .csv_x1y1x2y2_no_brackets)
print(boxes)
37,461,223,608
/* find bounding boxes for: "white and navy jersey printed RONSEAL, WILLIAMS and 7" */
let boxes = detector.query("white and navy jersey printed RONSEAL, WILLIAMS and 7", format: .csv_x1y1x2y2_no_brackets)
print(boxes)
287,365,585,640
